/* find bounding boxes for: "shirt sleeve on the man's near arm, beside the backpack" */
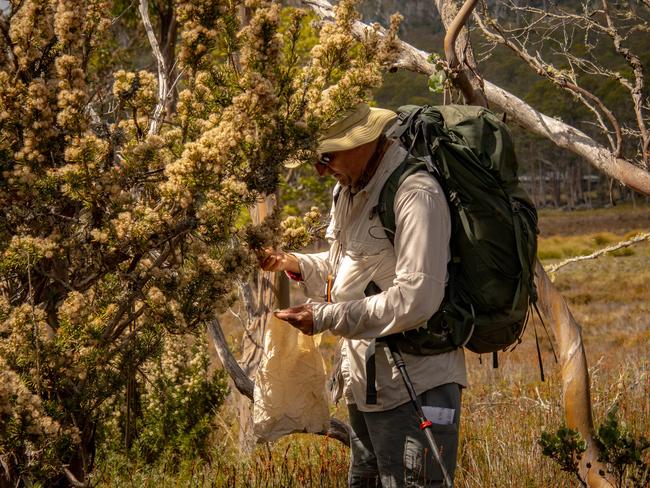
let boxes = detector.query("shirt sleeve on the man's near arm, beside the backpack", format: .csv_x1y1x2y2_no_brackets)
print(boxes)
314,173,451,339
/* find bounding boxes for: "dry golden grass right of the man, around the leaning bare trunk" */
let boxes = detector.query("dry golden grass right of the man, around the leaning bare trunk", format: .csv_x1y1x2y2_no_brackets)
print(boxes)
448,222,650,488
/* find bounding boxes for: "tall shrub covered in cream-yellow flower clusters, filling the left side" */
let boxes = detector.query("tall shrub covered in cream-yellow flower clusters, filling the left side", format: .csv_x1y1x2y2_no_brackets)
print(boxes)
0,0,396,485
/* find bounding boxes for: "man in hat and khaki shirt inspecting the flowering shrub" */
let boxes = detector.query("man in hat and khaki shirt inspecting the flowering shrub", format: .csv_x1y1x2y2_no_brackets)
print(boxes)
261,104,466,488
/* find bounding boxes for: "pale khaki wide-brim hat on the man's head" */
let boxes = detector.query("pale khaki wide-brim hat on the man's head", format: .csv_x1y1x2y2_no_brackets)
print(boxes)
317,103,397,154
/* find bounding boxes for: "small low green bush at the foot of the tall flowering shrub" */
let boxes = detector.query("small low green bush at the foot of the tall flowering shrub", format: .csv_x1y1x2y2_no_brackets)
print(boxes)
102,336,228,464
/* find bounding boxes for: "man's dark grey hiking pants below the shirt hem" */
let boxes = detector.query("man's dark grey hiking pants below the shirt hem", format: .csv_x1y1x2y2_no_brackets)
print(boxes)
348,383,461,488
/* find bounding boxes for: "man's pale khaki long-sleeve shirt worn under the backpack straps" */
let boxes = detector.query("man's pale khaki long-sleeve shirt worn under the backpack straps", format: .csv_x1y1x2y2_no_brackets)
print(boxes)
295,143,467,412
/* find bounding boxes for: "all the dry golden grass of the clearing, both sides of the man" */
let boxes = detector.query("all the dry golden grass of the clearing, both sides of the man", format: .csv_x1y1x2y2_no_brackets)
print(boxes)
97,207,650,488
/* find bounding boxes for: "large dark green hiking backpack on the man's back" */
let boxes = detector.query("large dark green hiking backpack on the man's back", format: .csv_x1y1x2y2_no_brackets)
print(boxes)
376,105,538,354
